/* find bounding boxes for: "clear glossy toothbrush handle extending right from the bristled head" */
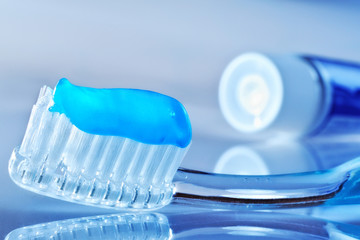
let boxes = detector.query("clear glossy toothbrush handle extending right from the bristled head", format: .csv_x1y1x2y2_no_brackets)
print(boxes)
174,168,349,208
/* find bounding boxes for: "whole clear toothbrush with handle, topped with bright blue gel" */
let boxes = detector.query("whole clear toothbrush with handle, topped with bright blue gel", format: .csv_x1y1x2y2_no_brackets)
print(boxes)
9,79,360,209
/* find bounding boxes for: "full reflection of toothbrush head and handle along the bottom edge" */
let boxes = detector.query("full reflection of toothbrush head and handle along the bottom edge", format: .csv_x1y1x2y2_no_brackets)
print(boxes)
6,211,360,240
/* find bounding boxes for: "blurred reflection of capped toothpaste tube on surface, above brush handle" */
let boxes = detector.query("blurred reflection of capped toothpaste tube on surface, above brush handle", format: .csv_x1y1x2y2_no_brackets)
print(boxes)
214,141,360,175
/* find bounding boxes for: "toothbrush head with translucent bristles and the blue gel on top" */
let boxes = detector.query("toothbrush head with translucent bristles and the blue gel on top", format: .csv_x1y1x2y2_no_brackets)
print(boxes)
9,79,191,209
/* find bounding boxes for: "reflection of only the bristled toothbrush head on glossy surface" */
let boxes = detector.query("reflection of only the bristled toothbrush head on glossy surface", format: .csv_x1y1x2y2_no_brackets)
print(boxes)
6,213,171,240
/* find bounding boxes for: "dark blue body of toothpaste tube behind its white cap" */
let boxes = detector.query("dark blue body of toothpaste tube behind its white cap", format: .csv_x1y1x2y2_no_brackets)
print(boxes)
304,56,360,134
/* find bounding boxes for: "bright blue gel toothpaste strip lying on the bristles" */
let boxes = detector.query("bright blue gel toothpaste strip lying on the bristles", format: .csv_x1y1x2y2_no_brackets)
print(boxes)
49,78,192,148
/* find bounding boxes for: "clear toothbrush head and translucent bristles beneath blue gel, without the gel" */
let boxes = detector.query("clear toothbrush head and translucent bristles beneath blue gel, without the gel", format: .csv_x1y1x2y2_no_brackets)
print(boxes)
9,87,188,208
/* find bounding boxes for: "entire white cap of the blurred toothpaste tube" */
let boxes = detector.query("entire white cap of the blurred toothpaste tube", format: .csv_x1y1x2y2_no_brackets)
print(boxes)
219,53,324,136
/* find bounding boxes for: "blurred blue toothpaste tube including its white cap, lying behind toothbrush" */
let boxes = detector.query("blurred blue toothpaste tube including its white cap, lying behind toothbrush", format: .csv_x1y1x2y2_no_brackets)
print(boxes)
219,53,360,138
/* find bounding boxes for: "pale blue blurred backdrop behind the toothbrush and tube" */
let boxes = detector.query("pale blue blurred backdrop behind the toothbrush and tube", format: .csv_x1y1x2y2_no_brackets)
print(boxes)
0,0,360,237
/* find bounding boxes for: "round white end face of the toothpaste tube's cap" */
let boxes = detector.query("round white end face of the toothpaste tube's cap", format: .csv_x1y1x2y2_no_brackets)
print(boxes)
219,54,283,133
